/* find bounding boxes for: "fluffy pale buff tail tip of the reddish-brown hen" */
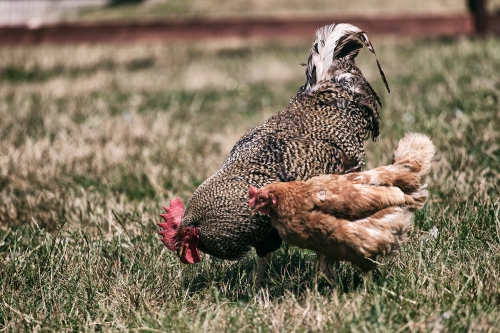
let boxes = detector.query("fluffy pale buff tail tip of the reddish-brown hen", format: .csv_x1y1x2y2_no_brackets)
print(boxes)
392,133,436,177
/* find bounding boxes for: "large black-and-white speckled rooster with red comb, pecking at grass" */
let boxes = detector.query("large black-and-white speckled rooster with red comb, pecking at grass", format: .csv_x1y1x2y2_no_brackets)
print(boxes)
158,24,389,277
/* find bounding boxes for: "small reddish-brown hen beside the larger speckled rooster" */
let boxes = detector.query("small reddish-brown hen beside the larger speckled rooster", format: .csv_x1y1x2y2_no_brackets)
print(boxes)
249,133,434,273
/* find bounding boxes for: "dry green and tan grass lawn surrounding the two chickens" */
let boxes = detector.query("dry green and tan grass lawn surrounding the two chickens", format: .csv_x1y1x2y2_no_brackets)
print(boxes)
0,38,500,332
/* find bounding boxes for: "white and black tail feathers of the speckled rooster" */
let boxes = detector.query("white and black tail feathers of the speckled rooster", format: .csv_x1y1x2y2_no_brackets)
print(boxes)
305,23,390,93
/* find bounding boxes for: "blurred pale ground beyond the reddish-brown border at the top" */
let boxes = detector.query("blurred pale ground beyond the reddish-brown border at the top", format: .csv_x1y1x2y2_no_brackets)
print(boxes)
0,0,500,25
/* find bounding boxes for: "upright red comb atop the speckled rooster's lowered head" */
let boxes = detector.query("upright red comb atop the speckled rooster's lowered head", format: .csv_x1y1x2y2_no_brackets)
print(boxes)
157,198,184,251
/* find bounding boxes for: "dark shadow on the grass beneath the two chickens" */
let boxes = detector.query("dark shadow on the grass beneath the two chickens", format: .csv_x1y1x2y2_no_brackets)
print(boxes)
183,244,385,302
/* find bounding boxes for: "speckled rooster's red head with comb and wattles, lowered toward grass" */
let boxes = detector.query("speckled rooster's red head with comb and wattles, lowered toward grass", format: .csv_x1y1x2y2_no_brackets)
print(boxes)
157,199,200,264
